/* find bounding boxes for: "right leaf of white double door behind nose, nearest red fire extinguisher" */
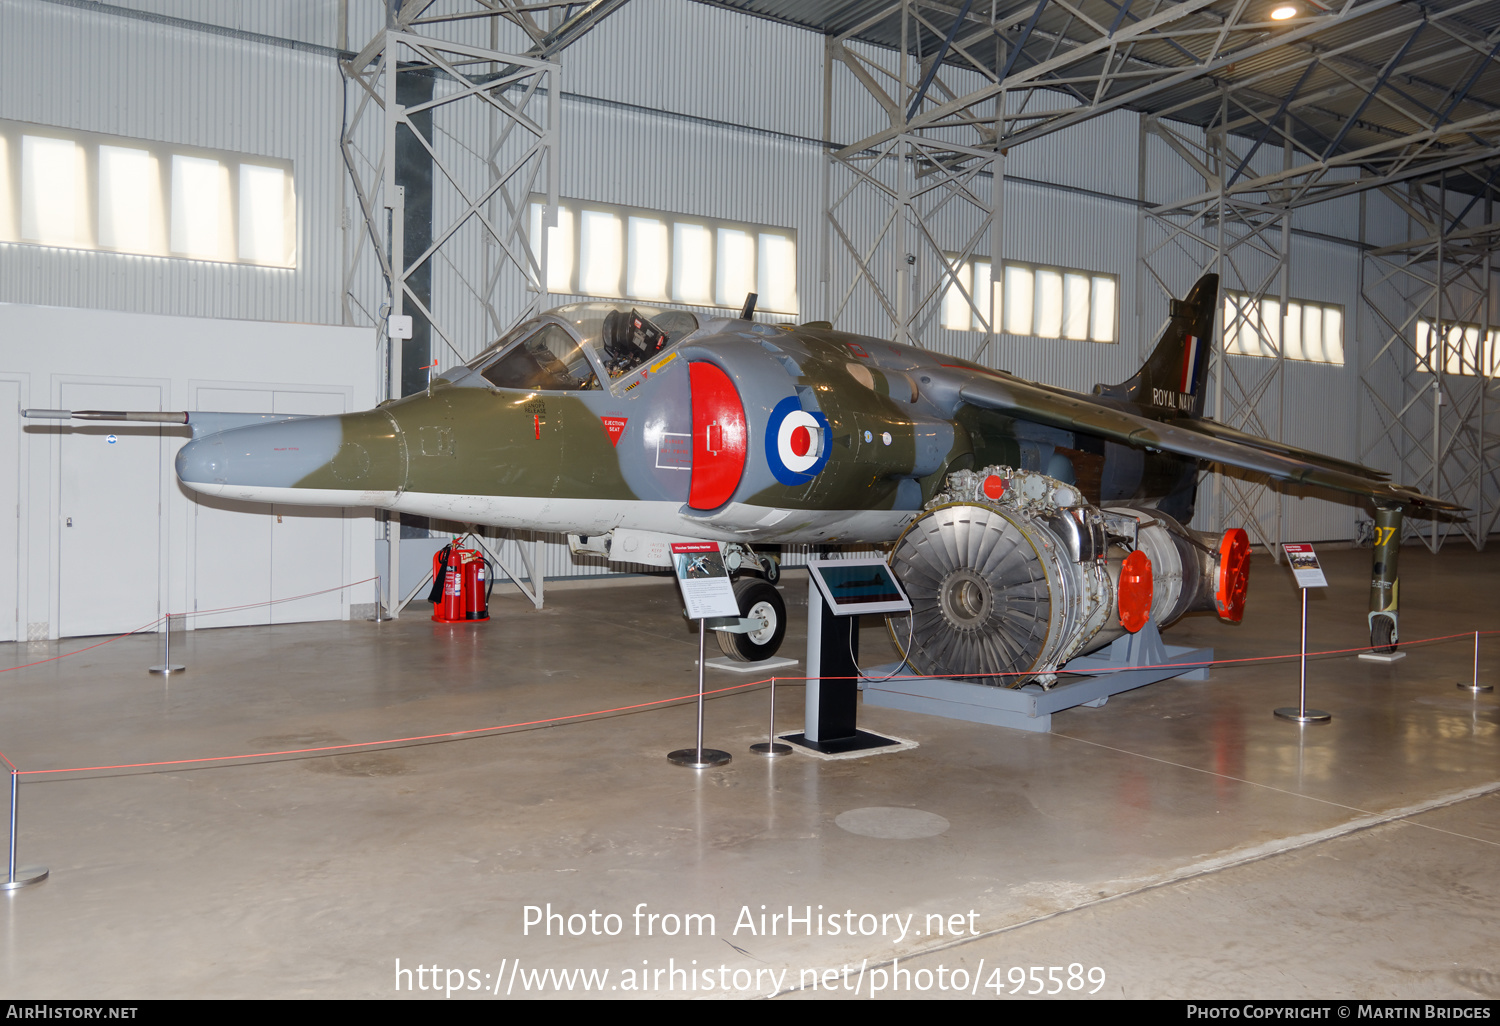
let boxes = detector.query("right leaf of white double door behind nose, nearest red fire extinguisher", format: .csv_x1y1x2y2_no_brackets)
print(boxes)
270,389,348,624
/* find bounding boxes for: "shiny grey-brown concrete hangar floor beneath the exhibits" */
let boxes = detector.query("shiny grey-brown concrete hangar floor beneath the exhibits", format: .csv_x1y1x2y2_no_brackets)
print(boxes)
0,546,1500,999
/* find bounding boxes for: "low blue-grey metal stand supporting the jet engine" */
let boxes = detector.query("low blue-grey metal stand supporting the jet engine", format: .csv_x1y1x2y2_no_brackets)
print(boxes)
861,621,1214,734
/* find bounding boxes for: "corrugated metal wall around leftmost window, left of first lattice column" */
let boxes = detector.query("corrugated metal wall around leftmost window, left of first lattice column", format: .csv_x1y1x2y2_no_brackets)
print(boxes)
0,0,344,324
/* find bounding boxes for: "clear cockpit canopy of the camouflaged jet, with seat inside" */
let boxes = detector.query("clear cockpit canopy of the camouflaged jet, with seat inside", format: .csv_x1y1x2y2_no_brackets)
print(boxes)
468,303,699,392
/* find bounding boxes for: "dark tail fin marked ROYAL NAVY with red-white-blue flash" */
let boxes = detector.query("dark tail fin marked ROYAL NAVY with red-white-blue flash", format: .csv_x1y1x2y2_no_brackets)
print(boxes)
1094,275,1218,417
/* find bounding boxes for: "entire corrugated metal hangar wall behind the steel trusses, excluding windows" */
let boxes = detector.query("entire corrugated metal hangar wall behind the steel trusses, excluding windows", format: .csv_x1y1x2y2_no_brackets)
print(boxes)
0,0,1482,576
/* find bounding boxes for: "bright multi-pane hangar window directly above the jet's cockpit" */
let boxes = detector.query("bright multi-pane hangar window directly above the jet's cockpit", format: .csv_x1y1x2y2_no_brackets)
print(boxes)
531,197,798,317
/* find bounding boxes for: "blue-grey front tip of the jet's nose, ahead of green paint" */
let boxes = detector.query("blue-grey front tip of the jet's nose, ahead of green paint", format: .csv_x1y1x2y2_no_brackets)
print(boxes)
177,417,344,498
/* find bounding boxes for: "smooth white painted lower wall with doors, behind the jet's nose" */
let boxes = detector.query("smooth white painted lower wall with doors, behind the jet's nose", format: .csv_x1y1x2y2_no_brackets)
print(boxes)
0,303,377,641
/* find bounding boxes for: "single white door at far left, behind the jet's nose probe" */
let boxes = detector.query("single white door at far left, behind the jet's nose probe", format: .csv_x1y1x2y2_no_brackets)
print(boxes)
57,381,165,638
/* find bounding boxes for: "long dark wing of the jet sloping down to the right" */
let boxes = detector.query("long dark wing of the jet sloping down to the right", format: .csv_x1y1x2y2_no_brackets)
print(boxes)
942,368,1464,513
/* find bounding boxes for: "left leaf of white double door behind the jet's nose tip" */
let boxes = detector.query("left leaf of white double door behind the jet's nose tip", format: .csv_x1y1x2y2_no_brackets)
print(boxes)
189,386,275,630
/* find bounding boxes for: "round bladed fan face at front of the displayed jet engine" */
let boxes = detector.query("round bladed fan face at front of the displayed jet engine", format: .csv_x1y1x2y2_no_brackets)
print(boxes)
890,506,1053,687
